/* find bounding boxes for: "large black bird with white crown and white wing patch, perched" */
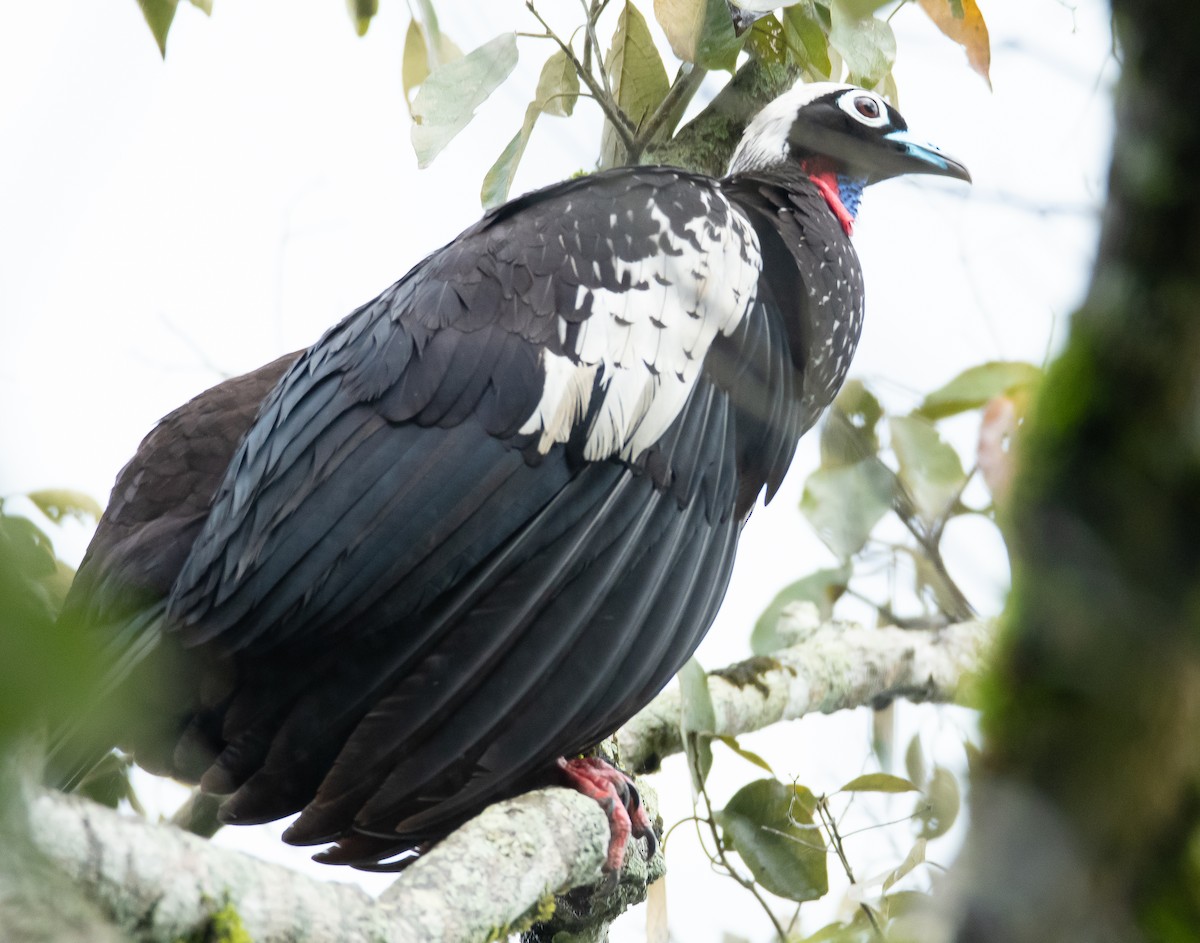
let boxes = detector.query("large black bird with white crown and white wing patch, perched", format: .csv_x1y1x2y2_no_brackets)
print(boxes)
54,83,970,870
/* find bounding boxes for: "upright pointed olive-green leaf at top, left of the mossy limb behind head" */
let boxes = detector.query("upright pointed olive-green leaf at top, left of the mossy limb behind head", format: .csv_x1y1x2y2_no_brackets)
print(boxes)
600,2,671,168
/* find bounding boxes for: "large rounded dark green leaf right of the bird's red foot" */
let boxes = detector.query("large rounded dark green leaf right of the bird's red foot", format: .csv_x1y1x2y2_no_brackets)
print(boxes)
716,779,829,901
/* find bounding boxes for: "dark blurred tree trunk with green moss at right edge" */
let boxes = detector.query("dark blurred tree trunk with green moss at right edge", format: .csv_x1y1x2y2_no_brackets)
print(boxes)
959,0,1200,941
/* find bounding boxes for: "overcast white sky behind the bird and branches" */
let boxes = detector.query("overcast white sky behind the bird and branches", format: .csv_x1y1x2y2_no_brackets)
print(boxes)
0,0,1116,943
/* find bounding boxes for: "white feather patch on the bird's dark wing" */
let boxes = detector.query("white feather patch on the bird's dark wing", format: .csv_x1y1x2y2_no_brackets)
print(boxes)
521,191,762,461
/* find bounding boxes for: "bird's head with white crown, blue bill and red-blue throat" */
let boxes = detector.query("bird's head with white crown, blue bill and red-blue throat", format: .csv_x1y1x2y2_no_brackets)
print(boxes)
730,82,971,233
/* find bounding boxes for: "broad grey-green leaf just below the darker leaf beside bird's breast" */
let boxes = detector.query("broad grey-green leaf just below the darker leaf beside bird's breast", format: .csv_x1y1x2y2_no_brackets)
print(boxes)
800,458,895,560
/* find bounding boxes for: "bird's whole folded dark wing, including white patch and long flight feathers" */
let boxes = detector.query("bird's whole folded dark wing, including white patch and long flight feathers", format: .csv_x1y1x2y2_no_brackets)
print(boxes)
150,170,758,841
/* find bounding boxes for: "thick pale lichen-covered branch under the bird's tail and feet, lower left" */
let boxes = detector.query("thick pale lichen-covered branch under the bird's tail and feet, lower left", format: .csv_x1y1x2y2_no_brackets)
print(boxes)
22,788,608,943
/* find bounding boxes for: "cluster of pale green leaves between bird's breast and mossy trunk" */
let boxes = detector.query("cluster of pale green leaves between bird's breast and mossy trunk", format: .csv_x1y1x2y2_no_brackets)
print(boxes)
752,361,1042,638
